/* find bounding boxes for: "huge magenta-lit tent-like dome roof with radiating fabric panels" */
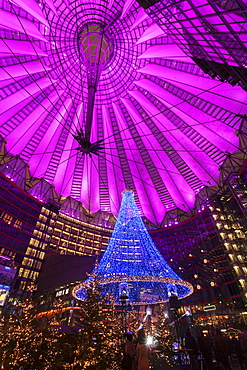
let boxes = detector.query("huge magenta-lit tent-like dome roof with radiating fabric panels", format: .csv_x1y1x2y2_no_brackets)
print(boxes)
0,0,247,226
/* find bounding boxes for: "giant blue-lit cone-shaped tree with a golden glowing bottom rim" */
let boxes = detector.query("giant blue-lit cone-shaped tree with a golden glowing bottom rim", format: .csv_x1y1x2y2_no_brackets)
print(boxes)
73,190,193,305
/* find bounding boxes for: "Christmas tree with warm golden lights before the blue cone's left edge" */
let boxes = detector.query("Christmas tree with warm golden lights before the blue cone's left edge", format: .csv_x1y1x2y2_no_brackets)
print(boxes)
72,277,123,370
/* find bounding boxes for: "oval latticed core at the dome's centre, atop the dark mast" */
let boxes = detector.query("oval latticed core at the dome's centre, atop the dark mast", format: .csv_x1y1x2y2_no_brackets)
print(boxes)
79,24,113,68
